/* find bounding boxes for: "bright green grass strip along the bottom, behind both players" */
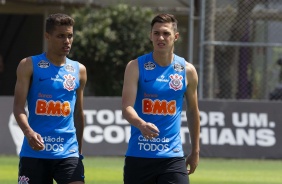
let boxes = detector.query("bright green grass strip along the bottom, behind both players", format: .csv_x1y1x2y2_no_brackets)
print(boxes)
0,156,282,184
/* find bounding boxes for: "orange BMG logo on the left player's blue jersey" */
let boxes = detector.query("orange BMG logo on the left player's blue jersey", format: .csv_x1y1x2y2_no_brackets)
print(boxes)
35,99,71,117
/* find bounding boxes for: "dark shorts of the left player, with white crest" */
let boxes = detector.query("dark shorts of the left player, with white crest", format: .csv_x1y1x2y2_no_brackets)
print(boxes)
18,157,84,184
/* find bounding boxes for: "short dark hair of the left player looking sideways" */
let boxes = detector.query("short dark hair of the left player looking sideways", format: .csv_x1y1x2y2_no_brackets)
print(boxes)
45,13,74,33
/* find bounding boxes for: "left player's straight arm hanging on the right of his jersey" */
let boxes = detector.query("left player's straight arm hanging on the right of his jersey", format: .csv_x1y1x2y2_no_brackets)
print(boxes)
74,64,87,154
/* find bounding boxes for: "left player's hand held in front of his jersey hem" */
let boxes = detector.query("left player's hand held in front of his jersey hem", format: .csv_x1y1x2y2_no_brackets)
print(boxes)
26,131,45,151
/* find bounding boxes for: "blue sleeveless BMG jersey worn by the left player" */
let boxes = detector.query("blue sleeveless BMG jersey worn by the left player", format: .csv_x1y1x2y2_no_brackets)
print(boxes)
20,53,79,159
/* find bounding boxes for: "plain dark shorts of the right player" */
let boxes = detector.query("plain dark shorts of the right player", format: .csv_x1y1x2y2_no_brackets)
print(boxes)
123,157,189,184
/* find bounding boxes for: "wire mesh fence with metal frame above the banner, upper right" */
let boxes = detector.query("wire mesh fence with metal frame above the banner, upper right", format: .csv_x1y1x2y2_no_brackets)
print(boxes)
199,0,282,100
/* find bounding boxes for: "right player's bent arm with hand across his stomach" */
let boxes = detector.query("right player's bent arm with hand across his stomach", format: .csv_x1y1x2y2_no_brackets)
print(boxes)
122,60,159,139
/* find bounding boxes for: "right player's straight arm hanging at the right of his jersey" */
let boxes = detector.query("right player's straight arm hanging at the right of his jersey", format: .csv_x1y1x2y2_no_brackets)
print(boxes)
185,62,200,174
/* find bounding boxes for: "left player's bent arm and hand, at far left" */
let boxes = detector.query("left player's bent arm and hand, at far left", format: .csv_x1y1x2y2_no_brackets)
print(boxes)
13,57,44,150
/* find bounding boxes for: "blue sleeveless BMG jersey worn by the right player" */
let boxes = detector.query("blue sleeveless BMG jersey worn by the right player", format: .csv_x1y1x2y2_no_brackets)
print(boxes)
126,53,186,158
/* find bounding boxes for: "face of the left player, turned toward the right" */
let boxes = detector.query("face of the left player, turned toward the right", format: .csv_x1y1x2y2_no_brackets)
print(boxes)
46,26,73,56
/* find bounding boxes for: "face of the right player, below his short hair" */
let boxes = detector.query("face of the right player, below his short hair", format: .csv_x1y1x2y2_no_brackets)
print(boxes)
150,23,179,52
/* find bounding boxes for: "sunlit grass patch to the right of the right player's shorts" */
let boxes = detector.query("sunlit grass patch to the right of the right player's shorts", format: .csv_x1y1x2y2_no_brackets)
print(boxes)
190,159,282,184
